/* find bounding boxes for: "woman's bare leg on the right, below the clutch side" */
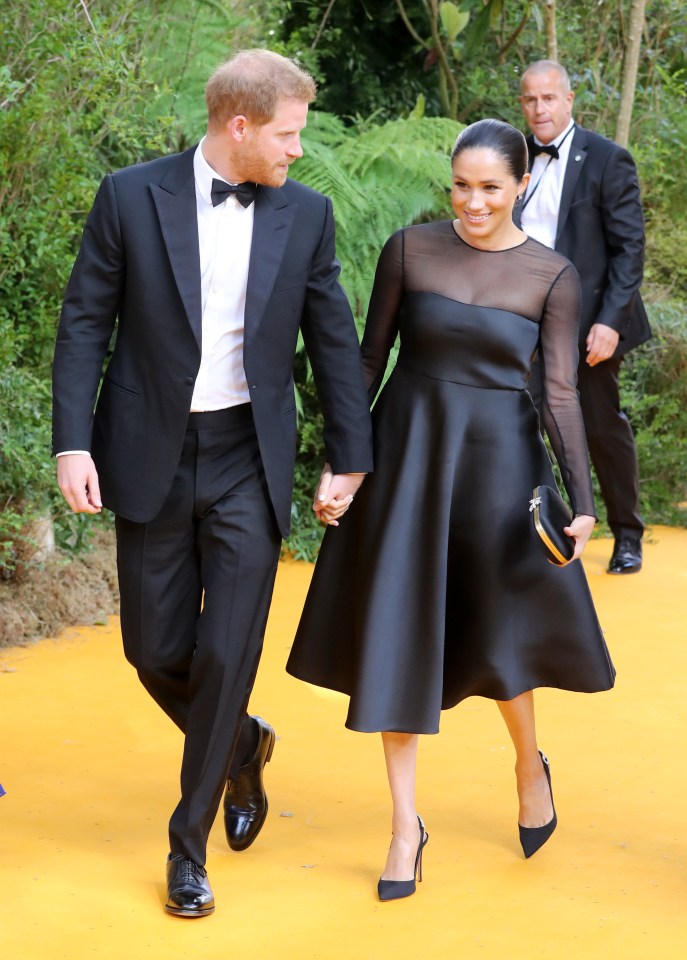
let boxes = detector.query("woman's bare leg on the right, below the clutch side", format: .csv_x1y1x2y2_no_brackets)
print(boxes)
496,690,553,827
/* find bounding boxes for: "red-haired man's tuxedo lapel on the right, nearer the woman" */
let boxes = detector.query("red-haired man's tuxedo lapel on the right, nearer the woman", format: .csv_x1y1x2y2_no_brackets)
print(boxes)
244,187,298,343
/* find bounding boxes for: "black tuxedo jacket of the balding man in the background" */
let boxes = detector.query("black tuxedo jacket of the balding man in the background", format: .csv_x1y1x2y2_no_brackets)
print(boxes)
515,126,651,357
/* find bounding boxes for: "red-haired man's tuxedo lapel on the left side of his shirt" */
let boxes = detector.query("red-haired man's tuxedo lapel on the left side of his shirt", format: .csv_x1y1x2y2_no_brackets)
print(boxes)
150,147,202,346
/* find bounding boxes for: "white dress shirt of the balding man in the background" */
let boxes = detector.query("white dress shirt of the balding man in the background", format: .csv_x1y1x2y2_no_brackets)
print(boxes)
520,120,574,250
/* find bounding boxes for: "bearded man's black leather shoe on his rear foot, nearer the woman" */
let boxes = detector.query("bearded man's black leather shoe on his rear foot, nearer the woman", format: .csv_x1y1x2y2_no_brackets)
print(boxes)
224,717,275,850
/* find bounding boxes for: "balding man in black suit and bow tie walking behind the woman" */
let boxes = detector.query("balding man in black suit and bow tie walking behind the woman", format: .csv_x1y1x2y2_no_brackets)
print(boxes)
516,60,651,573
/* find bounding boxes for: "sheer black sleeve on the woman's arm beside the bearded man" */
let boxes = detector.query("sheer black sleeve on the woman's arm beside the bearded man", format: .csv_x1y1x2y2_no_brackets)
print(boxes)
361,230,404,404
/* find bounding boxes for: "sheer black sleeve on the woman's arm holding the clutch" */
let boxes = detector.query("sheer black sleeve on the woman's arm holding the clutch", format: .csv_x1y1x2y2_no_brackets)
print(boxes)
540,265,596,517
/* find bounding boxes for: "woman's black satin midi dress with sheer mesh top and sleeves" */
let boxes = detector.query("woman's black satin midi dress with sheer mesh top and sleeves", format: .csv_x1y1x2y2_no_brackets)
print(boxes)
287,222,615,733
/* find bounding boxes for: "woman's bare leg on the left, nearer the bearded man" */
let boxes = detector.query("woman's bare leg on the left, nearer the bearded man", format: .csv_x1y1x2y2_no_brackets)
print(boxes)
382,733,420,880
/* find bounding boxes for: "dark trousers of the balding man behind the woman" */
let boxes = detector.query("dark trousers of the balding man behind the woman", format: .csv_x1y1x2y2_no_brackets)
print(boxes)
528,358,644,539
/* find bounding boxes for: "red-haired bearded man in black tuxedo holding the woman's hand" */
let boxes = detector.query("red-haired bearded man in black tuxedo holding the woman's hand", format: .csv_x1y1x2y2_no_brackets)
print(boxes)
53,50,372,917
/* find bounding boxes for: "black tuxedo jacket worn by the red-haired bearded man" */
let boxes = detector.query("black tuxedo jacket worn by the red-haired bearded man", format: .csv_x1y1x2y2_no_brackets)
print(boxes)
53,147,372,536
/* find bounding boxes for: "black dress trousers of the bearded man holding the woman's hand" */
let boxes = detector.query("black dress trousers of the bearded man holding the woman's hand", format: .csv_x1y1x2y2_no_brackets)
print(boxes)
116,404,281,865
